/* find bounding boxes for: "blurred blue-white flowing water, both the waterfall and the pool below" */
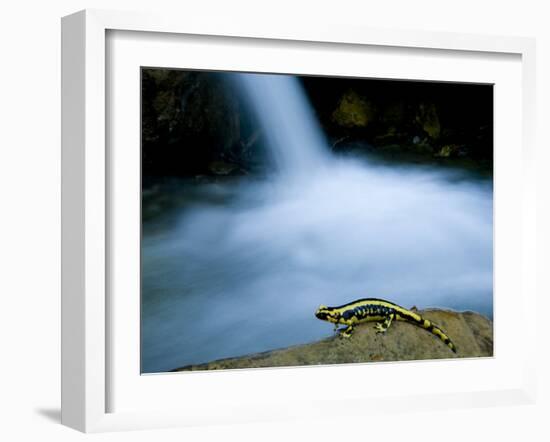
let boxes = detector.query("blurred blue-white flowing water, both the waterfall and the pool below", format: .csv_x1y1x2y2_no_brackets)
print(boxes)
142,74,493,373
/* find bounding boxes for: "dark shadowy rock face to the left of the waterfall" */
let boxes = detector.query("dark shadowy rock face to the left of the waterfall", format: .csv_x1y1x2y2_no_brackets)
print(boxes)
142,69,246,176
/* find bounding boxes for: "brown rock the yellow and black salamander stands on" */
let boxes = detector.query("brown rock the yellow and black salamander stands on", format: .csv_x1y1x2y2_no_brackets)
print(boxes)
175,309,493,371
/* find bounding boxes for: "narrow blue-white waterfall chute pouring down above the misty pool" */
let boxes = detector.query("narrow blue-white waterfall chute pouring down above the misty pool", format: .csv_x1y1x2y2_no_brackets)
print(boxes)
236,74,328,176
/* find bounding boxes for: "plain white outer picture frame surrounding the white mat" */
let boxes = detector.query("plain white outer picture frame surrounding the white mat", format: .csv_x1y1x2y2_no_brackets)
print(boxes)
62,10,536,432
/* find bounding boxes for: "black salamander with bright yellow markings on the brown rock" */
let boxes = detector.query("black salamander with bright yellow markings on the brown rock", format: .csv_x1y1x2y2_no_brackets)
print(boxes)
315,298,456,353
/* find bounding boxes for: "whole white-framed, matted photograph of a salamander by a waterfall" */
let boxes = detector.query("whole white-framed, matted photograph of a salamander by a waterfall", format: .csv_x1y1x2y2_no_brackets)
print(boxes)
62,10,536,432
